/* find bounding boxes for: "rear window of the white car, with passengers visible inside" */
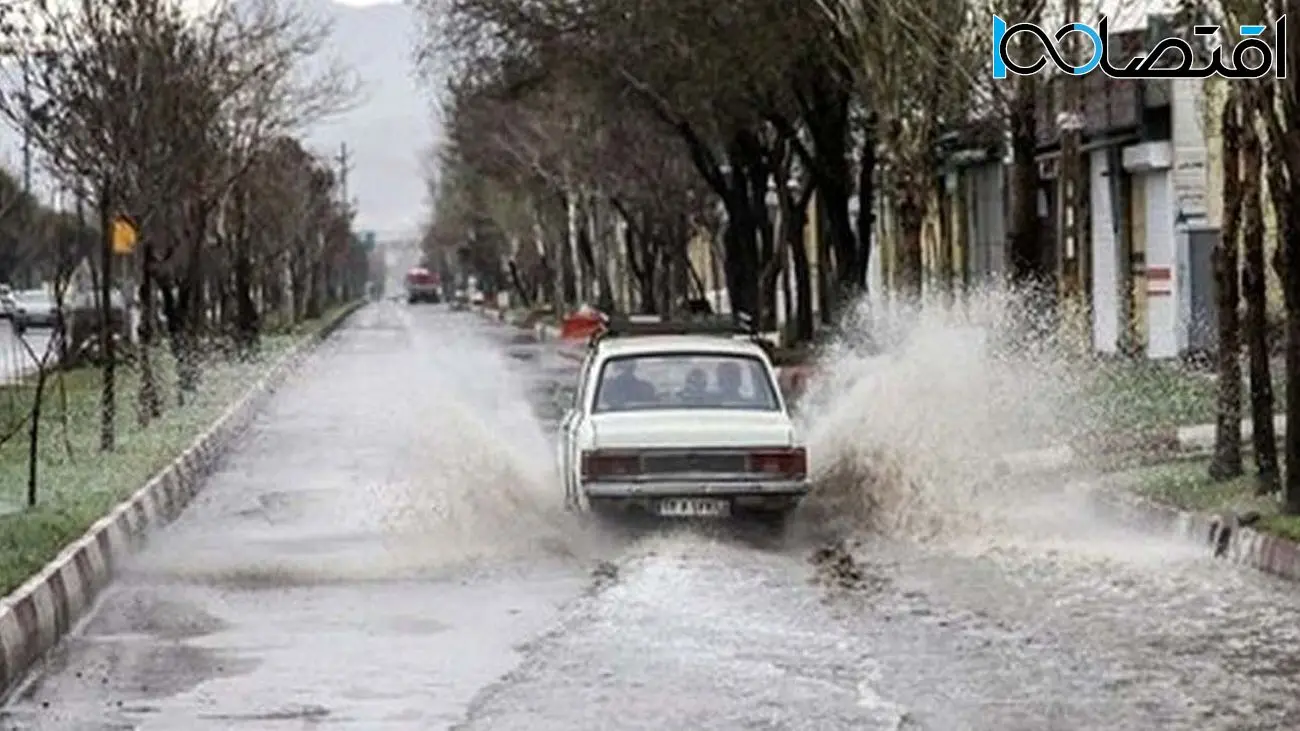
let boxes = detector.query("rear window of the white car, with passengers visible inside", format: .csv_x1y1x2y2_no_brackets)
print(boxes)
593,352,780,412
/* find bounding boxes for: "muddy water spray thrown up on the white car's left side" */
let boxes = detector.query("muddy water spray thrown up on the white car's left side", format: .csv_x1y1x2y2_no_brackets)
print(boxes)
366,304,608,557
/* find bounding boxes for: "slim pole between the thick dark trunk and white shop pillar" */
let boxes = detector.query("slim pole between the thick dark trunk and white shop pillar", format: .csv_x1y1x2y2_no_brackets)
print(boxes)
1057,0,1088,330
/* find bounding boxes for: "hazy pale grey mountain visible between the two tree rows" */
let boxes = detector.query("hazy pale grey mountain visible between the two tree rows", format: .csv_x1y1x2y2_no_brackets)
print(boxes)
0,0,438,238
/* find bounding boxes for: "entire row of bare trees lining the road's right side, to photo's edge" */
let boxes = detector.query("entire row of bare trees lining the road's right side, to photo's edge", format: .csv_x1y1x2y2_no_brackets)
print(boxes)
421,0,1300,512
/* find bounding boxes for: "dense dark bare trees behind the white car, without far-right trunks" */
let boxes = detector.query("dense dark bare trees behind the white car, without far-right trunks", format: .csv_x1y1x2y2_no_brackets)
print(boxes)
413,0,1013,341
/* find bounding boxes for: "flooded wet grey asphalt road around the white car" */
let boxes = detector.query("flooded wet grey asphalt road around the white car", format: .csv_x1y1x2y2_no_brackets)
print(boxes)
0,303,1300,731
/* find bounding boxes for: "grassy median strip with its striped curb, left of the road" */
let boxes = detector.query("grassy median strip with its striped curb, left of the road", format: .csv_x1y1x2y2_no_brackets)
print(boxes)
0,302,363,700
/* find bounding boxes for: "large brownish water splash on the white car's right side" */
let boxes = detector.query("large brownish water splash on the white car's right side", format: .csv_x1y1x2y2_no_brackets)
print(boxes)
801,289,1097,540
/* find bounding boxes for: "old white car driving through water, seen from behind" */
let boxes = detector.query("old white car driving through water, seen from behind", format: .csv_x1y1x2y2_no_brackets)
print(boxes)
559,316,809,527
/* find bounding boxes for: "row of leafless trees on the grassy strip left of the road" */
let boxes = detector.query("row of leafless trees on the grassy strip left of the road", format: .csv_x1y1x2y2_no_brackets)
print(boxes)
0,0,367,449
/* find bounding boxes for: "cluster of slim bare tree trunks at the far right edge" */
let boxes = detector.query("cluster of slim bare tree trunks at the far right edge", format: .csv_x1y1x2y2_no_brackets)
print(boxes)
1182,0,1300,515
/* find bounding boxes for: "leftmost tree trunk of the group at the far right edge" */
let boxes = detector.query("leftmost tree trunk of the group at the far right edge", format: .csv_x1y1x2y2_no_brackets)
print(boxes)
1209,95,1243,480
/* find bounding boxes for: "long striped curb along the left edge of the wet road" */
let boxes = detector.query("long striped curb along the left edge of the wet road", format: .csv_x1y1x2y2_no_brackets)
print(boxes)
0,300,365,702
